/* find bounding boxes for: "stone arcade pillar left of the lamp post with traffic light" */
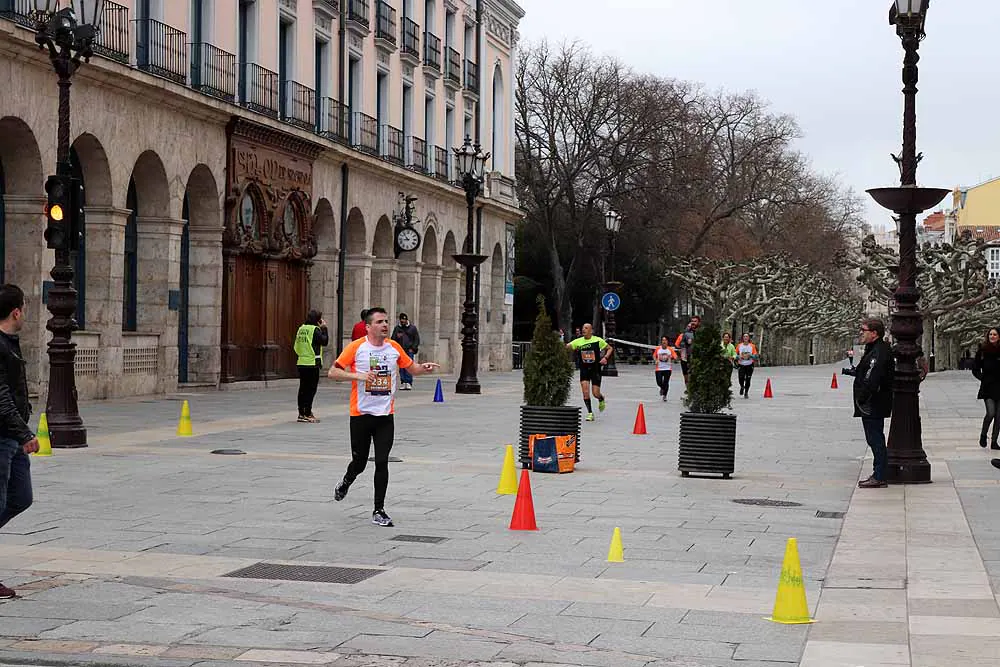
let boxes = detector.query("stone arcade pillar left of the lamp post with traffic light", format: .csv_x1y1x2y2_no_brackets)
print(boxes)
3,195,55,395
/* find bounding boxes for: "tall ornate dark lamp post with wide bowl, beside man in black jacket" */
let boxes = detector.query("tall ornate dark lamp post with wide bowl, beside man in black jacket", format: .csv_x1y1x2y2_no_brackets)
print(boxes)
868,0,949,484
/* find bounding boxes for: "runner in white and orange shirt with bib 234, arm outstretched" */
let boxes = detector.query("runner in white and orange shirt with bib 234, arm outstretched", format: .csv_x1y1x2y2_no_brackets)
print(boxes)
328,308,438,527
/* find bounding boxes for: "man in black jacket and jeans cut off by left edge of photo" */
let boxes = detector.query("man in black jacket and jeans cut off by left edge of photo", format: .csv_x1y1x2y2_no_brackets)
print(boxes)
0,285,38,599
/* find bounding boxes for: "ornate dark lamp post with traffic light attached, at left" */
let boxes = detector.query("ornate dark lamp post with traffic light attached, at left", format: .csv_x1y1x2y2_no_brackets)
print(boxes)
34,0,104,448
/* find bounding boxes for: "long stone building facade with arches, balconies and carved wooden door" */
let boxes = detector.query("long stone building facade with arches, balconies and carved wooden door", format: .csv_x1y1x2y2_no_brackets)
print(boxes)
0,0,524,398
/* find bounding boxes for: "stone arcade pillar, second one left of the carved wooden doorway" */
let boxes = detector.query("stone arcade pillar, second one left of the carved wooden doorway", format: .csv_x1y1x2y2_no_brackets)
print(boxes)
136,217,185,393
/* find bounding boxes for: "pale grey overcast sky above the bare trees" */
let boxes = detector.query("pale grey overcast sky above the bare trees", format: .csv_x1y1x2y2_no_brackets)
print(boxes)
519,0,1000,226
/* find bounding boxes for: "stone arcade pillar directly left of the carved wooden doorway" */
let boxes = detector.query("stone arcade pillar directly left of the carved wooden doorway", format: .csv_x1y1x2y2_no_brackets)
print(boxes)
188,225,222,385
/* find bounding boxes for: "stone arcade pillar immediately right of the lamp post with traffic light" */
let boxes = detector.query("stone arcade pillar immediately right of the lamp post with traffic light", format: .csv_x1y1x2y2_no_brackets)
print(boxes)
77,207,131,398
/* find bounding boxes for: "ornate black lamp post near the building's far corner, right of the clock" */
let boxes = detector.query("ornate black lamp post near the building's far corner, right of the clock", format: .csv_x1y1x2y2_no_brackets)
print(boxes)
452,137,490,394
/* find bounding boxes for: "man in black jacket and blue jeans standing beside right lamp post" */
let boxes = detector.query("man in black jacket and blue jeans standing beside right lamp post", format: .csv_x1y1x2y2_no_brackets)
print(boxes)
854,319,895,489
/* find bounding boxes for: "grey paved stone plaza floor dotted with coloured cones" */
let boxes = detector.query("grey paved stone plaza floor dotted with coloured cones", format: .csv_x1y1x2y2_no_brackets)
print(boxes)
0,366,1000,667
